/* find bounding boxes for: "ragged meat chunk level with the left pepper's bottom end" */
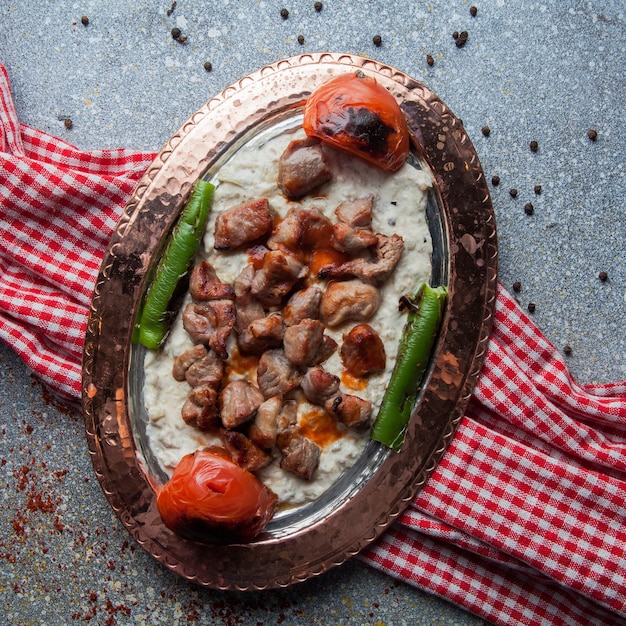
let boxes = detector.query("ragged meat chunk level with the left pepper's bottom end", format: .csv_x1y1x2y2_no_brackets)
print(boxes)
183,300,236,359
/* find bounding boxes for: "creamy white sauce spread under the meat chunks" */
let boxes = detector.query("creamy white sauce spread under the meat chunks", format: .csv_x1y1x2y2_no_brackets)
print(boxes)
143,123,432,507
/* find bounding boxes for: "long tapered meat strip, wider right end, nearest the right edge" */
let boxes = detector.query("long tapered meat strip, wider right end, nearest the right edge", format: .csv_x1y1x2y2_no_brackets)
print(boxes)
318,234,404,283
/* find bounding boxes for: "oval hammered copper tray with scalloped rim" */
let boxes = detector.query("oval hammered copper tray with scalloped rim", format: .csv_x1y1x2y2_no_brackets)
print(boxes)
83,54,497,590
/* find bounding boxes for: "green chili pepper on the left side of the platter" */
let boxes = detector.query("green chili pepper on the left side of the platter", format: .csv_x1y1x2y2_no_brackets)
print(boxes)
139,180,215,350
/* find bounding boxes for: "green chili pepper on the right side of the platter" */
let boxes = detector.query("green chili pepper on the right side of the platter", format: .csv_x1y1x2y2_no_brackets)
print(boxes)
372,283,447,450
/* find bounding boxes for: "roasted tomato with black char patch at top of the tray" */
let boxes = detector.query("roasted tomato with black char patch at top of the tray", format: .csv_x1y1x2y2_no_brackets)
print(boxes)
303,72,409,171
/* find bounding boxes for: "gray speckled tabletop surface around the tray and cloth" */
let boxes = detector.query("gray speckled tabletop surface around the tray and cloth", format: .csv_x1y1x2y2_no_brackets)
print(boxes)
0,0,626,626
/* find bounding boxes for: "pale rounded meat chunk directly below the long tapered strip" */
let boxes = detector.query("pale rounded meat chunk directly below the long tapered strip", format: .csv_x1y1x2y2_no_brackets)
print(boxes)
320,279,380,328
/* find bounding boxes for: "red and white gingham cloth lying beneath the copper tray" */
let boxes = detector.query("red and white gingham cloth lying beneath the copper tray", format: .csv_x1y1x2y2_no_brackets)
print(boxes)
0,64,626,625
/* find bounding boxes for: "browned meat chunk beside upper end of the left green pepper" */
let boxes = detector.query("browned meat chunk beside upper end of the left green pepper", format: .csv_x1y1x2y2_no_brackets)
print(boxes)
214,198,273,250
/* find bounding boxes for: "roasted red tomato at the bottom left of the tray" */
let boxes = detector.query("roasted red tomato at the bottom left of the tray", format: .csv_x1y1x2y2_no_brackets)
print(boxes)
157,450,278,543
